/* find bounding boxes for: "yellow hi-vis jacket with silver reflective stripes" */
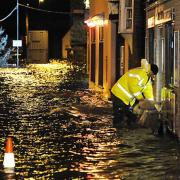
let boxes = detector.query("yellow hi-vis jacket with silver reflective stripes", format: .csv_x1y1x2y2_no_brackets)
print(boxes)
111,67,154,106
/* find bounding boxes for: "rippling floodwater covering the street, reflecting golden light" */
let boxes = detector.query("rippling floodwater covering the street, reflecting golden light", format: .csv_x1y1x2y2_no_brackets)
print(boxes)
0,63,180,180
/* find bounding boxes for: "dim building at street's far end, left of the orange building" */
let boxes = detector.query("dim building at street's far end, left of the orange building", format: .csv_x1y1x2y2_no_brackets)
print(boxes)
62,0,86,64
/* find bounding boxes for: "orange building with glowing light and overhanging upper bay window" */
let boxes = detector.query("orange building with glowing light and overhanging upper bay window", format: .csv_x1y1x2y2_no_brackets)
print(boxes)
85,0,145,98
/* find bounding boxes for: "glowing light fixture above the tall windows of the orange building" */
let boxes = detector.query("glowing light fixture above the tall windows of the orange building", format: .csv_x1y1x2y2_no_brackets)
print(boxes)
84,14,106,28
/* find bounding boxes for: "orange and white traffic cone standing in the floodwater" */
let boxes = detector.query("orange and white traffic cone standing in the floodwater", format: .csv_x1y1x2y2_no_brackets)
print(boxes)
3,137,15,168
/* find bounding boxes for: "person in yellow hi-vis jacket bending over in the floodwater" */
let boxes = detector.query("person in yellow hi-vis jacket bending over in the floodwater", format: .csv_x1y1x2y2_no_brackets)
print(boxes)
111,61,158,126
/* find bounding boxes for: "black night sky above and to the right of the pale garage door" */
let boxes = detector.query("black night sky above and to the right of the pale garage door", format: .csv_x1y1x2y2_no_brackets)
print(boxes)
0,0,72,58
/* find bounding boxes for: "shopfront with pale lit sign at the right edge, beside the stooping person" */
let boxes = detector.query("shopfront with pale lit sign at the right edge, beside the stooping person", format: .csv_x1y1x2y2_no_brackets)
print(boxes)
145,0,180,138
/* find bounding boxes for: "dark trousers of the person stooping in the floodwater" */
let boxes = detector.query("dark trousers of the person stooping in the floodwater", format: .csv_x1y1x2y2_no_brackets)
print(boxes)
111,94,136,125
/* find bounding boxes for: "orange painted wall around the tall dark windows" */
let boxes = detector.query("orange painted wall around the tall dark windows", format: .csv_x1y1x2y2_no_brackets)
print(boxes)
88,0,116,98
